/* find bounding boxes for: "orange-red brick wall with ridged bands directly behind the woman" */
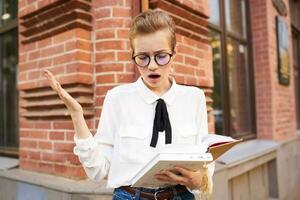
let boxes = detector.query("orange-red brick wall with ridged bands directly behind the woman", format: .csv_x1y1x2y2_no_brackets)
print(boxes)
18,0,214,178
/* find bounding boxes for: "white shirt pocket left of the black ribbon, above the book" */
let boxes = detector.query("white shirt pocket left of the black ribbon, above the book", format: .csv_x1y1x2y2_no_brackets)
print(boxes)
119,125,154,163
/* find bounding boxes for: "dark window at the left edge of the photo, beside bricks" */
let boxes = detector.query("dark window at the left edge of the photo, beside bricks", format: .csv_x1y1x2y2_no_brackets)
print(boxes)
0,0,19,156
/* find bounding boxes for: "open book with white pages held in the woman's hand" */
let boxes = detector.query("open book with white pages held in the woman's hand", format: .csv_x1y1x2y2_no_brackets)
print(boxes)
131,134,242,188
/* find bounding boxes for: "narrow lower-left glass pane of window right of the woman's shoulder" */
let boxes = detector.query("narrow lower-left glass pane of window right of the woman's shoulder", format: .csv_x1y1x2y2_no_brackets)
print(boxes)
210,31,224,134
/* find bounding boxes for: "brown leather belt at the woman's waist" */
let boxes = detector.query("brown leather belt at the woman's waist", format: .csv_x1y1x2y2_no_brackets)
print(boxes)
120,185,187,200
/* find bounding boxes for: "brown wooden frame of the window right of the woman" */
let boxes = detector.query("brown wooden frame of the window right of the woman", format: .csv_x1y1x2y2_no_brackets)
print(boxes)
208,0,256,140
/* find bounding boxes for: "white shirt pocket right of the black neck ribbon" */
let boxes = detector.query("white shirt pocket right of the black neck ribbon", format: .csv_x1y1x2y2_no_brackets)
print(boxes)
176,123,198,144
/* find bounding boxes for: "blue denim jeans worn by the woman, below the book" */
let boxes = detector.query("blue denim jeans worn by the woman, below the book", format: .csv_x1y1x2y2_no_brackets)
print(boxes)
112,188,195,200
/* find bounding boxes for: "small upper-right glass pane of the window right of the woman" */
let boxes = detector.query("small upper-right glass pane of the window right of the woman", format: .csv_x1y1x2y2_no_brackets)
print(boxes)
225,0,246,37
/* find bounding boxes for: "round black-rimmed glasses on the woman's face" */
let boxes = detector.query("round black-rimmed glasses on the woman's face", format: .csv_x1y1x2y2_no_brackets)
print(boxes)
132,52,173,67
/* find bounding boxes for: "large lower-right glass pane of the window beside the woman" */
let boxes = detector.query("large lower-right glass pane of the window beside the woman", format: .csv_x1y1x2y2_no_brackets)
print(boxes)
227,38,251,135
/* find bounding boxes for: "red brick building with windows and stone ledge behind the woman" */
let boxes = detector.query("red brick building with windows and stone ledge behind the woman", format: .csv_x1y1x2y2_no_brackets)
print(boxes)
0,0,300,199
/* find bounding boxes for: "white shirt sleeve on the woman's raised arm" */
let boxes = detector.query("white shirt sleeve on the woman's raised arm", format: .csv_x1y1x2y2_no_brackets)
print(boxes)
74,91,116,181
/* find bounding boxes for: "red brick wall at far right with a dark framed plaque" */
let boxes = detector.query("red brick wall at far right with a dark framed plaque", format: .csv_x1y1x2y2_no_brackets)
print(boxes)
250,0,296,140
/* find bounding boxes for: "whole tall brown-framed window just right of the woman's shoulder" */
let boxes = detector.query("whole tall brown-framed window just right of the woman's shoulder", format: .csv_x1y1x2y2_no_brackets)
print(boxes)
209,0,255,139
